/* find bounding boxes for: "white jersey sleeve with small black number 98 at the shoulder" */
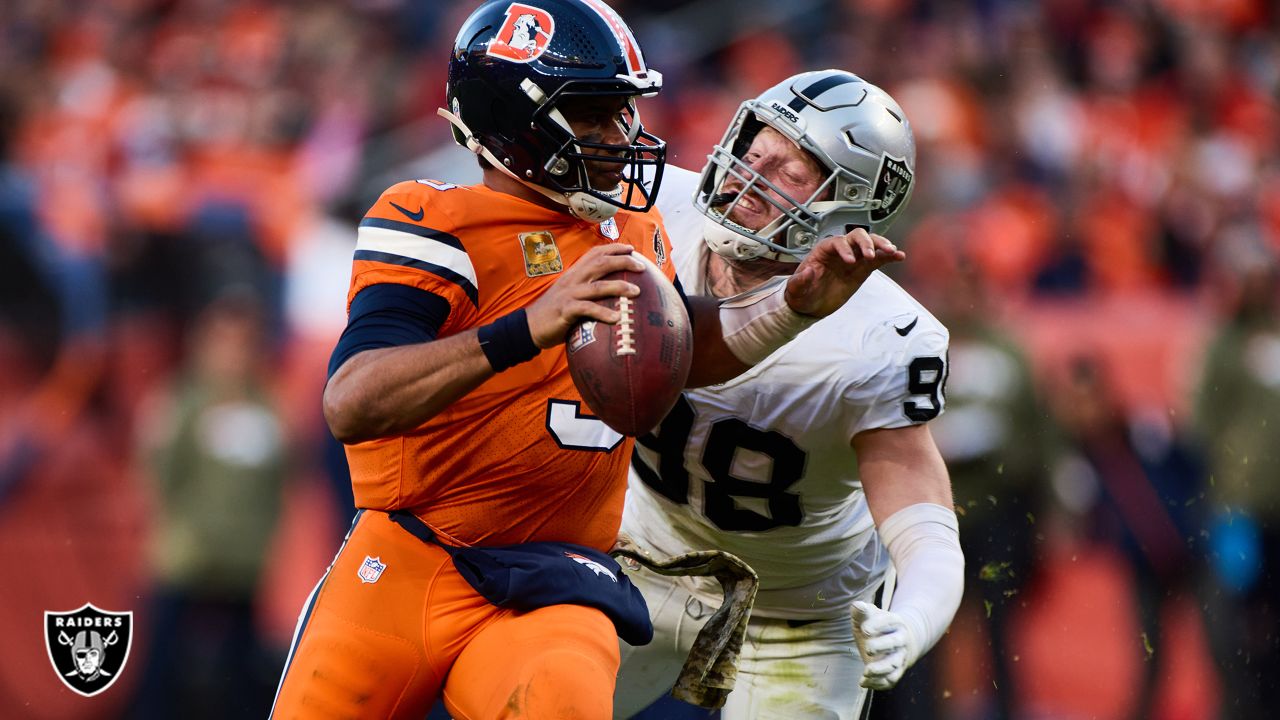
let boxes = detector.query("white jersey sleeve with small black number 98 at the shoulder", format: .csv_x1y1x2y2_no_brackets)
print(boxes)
841,318,950,438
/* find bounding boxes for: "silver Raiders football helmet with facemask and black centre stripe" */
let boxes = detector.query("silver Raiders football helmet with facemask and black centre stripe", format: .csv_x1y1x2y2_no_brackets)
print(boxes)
694,70,915,263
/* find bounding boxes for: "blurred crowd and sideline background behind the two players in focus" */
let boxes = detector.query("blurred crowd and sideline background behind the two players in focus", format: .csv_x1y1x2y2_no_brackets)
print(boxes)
0,0,1280,720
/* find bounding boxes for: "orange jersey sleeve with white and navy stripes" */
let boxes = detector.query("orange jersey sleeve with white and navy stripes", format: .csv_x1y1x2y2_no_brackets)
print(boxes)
347,181,480,334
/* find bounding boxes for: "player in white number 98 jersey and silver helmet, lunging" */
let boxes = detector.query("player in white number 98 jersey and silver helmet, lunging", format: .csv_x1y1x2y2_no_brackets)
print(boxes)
614,70,964,720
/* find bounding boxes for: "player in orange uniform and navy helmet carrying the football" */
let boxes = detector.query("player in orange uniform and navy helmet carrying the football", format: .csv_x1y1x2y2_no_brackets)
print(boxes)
273,0,905,720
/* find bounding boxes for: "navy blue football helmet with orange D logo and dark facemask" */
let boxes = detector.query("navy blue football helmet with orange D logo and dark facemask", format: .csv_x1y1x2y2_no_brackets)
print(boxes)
440,0,667,222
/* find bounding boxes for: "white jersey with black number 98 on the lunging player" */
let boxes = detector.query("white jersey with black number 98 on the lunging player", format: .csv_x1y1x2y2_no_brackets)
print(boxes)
622,165,947,619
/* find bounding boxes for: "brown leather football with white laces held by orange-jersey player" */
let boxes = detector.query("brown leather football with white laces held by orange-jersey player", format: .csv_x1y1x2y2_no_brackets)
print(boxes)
566,254,694,436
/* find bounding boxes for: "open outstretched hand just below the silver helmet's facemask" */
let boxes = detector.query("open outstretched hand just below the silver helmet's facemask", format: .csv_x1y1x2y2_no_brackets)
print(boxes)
783,228,906,318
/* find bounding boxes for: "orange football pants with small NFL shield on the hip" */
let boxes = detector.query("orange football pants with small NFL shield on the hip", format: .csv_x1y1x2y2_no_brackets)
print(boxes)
271,510,618,720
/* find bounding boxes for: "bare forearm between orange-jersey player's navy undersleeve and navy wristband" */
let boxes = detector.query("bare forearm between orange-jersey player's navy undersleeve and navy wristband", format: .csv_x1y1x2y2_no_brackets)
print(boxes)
324,331,494,445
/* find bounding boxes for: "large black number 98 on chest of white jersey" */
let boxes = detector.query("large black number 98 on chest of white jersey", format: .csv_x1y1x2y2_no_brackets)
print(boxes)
631,395,805,533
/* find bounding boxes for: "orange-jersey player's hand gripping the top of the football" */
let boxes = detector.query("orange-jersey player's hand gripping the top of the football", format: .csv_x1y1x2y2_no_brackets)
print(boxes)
525,242,644,348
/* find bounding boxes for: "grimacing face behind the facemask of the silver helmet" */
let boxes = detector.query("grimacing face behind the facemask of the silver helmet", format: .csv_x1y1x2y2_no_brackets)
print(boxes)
713,126,824,231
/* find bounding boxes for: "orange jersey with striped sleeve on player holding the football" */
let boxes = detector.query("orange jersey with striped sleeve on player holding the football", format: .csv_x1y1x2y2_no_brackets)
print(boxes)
347,181,675,550
